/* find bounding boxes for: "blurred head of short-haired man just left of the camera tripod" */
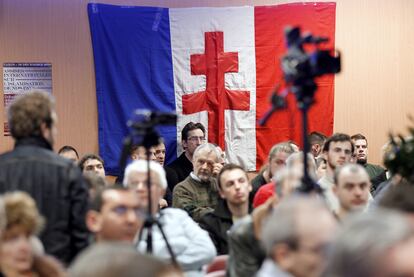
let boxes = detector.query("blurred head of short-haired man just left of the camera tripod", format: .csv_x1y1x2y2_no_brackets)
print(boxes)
86,186,144,242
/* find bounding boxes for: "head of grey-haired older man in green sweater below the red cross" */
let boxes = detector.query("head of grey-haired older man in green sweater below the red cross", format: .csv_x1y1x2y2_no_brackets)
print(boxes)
193,143,220,182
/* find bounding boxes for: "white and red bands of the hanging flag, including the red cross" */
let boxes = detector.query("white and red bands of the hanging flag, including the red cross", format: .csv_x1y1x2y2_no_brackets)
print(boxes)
169,2,335,170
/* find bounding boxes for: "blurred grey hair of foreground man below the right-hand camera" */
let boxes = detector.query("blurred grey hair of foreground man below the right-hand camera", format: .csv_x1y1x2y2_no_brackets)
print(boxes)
261,195,329,256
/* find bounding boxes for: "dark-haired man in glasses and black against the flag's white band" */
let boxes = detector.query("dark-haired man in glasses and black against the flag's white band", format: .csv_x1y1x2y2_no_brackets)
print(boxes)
169,122,206,182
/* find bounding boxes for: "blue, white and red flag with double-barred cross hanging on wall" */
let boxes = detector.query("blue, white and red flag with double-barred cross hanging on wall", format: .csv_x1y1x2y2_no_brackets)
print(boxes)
88,2,336,174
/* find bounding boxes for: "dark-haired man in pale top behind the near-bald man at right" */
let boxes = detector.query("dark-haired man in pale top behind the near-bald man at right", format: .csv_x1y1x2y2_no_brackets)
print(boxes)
318,133,354,212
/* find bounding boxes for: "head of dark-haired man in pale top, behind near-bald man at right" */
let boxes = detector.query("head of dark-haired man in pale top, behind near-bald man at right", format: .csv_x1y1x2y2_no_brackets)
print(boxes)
323,133,354,171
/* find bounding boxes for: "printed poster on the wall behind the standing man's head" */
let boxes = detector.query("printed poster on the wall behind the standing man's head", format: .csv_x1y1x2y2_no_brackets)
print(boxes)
3,63,52,136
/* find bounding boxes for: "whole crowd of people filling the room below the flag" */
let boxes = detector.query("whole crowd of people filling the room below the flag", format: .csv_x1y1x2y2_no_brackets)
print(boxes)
0,91,414,277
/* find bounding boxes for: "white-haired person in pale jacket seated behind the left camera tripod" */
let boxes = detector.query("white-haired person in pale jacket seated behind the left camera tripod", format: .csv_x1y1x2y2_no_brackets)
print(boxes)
124,160,216,276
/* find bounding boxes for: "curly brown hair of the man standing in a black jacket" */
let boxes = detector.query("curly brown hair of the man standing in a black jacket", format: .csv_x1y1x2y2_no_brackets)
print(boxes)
8,91,54,139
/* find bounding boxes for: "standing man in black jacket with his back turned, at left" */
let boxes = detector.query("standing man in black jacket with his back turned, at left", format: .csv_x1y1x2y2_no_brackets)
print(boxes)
0,92,88,264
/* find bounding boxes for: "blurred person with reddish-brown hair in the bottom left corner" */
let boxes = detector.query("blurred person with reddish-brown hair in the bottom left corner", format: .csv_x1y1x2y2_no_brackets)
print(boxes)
0,192,64,277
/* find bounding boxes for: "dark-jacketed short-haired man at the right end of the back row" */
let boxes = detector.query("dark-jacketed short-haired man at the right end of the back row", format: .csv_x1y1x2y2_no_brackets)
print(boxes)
351,134,387,193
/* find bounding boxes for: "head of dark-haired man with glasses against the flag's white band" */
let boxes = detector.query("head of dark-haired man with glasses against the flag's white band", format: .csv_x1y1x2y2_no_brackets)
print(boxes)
181,122,206,157
